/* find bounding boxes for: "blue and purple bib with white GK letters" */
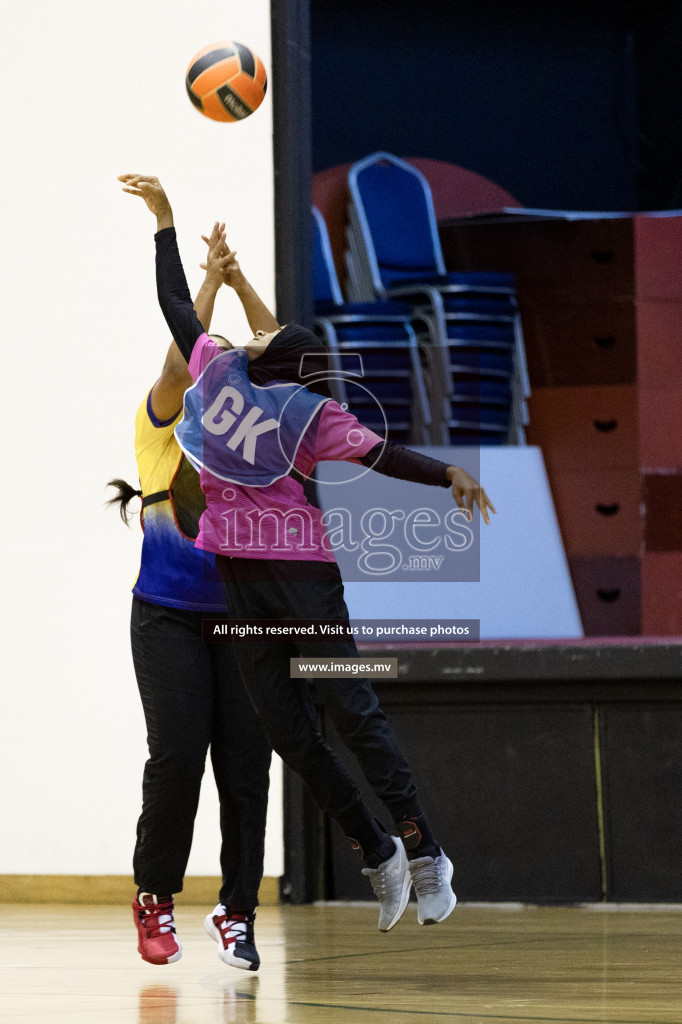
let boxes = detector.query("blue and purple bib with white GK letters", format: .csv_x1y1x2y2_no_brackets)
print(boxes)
175,350,329,487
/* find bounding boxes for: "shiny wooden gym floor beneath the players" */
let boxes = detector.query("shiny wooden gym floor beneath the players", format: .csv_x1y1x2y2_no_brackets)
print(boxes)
0,904,682,1024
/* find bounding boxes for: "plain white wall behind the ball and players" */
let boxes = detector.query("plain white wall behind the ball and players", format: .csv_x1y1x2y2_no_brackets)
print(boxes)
0,0,282,874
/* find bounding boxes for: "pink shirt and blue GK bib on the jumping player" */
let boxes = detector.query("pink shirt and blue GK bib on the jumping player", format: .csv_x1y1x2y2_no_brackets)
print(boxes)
175,325,383,562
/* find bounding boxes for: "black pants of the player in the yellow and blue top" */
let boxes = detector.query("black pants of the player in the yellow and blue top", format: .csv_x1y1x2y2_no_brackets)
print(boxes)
130,597,271,909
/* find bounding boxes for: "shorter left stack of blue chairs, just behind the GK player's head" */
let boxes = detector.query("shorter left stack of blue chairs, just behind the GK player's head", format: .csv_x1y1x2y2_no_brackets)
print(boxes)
312,207,431,444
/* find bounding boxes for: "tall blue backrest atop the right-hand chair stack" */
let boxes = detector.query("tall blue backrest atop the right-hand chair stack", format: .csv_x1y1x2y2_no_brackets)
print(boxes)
348,153,445,287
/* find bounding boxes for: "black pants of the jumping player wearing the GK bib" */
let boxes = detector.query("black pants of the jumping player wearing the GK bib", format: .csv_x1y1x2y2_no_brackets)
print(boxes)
216,555,421,852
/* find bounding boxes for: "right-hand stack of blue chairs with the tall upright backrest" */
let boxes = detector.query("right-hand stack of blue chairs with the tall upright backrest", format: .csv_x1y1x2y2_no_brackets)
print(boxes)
346,153,530,444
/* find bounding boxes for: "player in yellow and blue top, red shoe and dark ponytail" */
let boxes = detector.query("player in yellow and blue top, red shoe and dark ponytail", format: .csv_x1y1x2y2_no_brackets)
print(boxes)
107,224,274,971
